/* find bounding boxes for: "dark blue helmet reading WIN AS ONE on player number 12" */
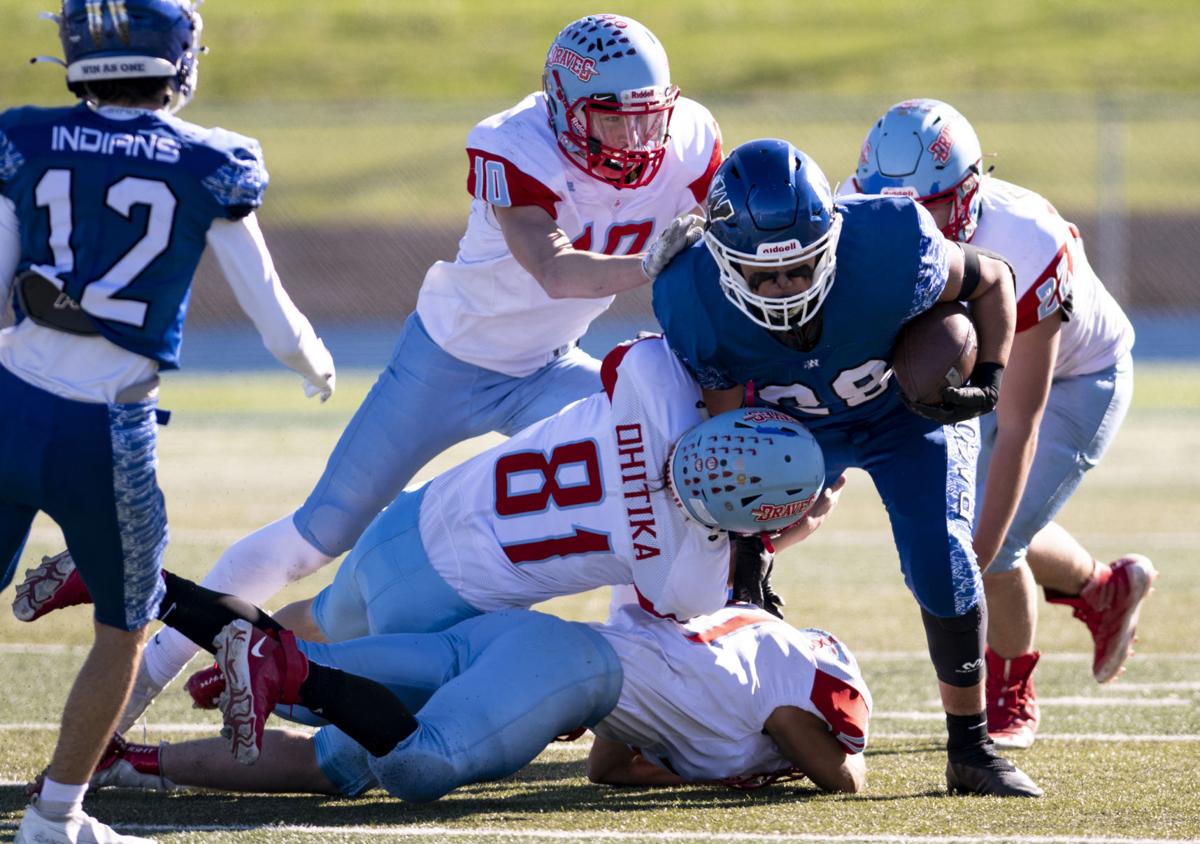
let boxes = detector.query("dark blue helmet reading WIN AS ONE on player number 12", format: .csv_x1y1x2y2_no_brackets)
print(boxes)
54,0,203,112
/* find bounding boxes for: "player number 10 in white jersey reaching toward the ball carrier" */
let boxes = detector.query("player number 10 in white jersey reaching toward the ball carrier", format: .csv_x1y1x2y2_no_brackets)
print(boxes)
14,9,721,728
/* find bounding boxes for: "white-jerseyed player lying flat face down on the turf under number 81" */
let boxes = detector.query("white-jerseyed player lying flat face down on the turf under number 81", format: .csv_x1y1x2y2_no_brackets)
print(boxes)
87,604,871,801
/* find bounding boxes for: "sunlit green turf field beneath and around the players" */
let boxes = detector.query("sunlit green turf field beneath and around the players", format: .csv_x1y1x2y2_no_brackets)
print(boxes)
0,366,1200,844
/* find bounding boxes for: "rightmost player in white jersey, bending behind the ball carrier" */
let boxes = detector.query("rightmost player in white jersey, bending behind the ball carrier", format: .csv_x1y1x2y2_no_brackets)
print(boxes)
853,100,1157,747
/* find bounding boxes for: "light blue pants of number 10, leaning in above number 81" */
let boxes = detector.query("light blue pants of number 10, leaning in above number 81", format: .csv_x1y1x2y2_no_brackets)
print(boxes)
295,313,601,557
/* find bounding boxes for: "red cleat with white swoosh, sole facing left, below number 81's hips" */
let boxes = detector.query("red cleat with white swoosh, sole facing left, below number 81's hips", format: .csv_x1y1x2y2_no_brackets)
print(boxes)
212,619,308,765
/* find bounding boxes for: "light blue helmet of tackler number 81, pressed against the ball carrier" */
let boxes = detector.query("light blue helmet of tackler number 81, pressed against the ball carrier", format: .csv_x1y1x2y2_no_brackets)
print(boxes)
668,407,824,533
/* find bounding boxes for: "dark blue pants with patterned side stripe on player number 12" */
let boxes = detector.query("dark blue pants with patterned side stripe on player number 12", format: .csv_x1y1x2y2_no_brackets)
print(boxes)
0,367,167,630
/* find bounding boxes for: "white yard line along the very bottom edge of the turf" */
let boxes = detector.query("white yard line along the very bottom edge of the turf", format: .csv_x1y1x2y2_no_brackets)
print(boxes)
0,824,1195,844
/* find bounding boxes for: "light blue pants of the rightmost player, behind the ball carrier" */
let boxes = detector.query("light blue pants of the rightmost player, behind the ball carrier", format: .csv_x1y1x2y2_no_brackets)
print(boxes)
978,355,1133,575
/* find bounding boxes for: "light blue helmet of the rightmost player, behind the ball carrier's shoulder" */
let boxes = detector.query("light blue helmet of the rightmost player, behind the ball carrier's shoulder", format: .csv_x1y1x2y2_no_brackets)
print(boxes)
854,100,983,241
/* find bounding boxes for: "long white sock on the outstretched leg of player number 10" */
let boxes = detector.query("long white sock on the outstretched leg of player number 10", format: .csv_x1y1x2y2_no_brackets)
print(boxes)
143,514,334,686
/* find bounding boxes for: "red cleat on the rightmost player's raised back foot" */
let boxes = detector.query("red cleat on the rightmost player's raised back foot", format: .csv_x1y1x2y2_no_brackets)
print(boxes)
1046,553,1158,683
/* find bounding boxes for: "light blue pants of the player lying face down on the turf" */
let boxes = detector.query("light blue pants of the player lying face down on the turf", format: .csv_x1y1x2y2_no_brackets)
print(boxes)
309,610,623,801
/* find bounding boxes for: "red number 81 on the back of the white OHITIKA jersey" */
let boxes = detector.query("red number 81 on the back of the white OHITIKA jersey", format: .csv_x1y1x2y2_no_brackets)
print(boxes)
496,439,612,564
